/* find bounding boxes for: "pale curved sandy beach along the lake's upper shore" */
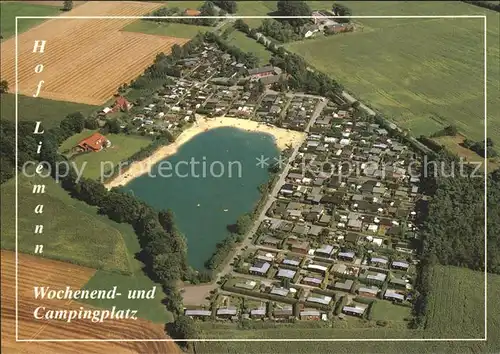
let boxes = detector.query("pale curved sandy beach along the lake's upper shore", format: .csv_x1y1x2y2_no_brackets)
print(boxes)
104,117,306,189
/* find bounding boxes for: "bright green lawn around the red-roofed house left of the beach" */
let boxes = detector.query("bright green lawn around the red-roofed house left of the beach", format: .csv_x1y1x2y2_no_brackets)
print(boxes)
59,130,151,179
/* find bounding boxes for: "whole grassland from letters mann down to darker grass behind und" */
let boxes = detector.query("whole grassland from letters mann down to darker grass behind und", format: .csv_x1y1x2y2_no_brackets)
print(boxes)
0,171,172,323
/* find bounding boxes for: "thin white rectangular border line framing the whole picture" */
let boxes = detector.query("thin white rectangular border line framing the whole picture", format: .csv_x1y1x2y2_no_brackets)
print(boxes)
15,15,488,342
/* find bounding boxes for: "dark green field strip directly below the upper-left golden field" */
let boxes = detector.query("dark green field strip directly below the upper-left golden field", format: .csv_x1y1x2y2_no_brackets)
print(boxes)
0,92,99,128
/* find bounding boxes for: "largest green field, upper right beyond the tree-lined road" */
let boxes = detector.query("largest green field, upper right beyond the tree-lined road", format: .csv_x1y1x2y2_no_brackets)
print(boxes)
286,1,500,143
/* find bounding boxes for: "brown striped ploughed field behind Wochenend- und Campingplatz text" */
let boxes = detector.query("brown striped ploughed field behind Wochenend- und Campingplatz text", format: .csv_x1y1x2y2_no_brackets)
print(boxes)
1,250,180,353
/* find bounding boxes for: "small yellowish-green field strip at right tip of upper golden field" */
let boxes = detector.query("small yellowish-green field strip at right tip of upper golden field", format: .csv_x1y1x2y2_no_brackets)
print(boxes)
123,20,214,39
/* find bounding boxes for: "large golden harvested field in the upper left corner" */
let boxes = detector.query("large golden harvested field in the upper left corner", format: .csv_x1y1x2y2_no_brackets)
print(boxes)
1,1,188,105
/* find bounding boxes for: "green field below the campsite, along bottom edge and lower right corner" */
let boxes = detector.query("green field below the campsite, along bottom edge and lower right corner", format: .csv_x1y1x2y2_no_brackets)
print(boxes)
196,266,500,354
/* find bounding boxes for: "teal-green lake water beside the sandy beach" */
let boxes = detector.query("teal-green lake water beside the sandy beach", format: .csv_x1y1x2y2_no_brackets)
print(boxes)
124,128,279,269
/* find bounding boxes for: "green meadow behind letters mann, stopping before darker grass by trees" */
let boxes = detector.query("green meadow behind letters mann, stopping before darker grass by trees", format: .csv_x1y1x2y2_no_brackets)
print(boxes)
0,175,131,272
